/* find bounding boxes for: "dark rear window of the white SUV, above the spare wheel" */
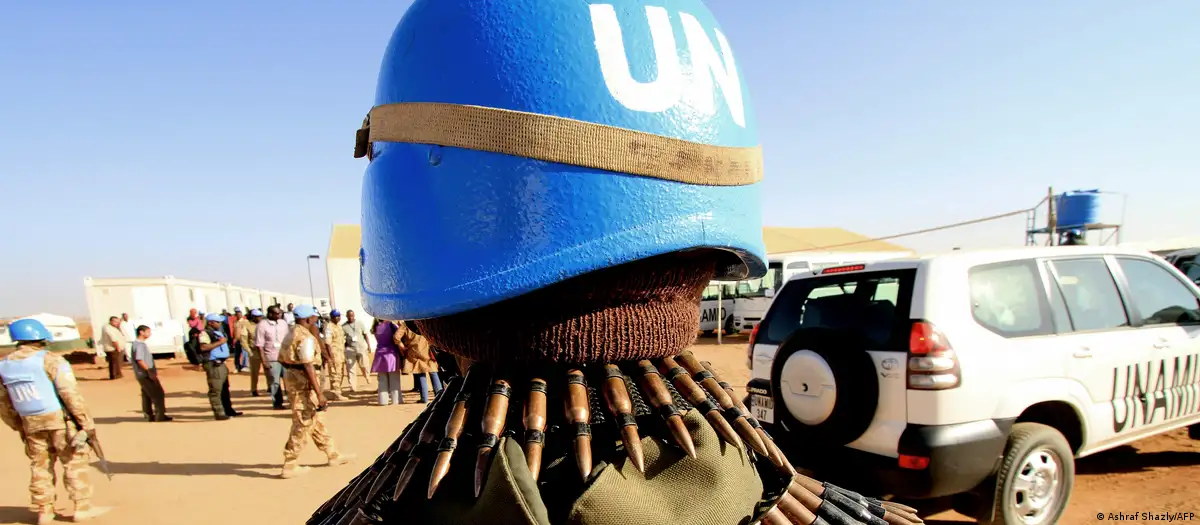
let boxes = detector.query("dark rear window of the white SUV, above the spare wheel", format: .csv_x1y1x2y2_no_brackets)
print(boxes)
756,270,917,351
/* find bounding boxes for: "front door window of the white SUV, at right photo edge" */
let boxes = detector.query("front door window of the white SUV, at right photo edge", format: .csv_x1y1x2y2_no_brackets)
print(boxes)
1117,258,1200,325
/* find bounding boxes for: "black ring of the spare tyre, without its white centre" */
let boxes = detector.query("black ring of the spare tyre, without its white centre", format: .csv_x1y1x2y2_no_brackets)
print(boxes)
770,328,880,446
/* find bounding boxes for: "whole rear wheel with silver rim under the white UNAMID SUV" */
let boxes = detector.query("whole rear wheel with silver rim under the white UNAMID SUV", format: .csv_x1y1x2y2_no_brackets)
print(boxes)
980,423,1075,525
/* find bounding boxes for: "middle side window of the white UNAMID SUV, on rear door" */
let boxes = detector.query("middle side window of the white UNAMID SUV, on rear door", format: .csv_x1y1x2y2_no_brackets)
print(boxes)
1050,259,1129,332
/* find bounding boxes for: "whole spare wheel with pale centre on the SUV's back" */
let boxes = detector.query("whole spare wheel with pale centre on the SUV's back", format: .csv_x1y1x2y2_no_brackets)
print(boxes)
770,328,880,446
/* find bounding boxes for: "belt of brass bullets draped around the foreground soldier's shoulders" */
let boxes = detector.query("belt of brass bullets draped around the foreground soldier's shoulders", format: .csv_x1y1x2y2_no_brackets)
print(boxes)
308,352,920,525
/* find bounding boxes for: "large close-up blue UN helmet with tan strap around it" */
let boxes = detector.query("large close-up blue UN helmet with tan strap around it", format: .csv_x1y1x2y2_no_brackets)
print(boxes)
355,0,766,319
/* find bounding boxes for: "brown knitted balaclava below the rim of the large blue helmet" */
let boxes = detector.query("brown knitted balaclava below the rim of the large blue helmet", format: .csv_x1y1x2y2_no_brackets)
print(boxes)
416,249,730,364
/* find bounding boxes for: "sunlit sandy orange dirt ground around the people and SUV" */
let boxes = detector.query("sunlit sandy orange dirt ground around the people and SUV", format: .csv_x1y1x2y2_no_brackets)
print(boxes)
0,338,1200,525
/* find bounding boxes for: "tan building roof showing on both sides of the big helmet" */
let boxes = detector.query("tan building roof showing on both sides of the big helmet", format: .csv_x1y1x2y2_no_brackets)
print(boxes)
328,224,911,259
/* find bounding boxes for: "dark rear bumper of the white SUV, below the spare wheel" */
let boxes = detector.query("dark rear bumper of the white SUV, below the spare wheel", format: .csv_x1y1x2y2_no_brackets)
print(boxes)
745,380,1015,499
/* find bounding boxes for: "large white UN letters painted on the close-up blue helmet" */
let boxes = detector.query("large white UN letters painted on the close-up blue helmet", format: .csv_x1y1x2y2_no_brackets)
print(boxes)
589,4,746,127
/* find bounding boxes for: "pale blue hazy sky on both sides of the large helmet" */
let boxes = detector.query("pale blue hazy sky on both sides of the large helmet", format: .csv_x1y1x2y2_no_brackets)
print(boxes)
0,0,1200,316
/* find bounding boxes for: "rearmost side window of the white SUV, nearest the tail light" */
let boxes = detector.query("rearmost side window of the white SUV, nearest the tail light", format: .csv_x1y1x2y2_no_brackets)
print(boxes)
967,260,1054,337
